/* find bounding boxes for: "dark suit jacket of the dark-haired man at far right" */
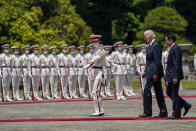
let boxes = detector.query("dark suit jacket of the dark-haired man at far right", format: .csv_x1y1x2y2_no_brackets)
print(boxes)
165,44,184,82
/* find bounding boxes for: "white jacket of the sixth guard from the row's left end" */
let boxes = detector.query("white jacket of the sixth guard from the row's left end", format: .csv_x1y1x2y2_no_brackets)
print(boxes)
49,54,59,76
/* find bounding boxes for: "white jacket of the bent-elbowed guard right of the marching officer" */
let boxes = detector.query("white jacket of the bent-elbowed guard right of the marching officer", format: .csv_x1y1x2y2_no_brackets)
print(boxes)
111,51,127,75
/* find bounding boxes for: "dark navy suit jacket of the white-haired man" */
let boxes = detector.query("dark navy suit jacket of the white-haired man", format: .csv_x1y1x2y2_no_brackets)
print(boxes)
145,40,164,79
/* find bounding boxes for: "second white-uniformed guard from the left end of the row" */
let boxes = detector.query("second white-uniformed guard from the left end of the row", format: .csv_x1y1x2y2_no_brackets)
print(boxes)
11,46,23,101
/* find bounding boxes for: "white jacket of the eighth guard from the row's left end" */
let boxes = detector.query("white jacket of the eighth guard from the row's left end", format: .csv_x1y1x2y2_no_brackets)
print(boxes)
68,54,79,75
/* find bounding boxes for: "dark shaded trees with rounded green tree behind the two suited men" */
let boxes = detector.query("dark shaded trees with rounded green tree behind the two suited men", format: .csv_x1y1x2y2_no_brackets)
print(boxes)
71,0,196,52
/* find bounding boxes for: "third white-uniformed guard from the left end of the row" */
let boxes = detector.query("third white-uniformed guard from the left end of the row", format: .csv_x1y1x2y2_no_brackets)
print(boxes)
21,45,32,100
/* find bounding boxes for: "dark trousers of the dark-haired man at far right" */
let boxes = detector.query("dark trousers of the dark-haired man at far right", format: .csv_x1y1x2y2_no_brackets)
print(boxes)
167,80,189,117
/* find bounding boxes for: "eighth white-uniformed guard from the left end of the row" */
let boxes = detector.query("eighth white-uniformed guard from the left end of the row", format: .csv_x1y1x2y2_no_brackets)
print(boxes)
68,46,79,98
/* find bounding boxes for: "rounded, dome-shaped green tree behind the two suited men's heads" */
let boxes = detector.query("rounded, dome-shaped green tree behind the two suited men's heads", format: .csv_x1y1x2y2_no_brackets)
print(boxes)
134,7,188,45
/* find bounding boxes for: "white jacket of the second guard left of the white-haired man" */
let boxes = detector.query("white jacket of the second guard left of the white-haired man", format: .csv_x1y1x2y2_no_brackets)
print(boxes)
127,53,136,74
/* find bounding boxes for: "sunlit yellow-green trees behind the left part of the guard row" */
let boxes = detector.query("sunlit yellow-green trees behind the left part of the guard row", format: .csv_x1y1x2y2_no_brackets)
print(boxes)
0,0,92,51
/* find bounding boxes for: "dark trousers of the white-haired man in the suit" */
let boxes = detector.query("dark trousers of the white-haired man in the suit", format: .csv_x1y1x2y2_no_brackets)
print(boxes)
143,78,167,114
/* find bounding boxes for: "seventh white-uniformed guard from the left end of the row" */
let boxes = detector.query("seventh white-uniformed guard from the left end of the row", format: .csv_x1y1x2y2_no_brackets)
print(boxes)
58,44,70,99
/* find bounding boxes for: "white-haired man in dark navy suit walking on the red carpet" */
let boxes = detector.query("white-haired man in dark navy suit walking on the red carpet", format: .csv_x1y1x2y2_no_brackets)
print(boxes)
139,30,167,118
